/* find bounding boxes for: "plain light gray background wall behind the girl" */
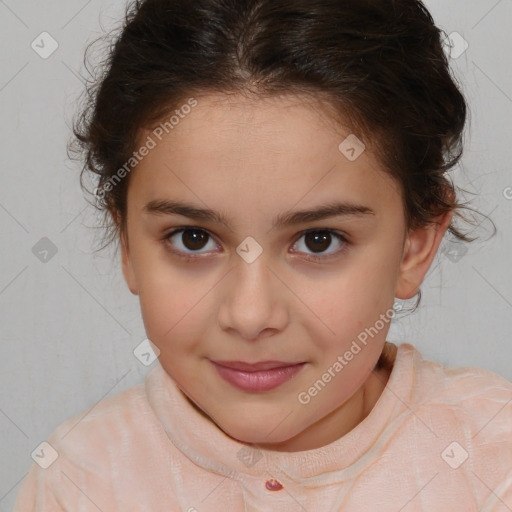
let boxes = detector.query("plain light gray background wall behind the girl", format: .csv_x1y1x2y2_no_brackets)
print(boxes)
0,0,512,511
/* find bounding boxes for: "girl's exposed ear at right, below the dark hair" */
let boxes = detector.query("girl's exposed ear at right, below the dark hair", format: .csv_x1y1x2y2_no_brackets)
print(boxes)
395,207,453,299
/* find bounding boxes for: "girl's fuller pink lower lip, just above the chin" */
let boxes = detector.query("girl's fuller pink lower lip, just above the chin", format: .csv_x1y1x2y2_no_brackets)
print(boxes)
213,363,306,391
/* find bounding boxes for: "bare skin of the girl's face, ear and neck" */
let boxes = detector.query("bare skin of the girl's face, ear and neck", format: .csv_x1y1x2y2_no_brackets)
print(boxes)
115,94,452,451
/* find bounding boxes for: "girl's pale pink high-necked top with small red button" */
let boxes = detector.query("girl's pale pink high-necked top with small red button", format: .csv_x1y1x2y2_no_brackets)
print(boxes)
13,343,512,512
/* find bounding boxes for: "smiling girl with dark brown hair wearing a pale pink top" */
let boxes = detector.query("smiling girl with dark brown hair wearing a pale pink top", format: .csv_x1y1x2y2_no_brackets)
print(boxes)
10,0,512,512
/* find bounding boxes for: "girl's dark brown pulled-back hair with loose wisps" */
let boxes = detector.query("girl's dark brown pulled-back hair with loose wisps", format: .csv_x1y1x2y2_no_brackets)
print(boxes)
68,0,492,320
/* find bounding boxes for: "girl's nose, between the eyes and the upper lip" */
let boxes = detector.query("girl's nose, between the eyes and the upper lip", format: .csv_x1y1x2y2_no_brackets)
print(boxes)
219,256,290,340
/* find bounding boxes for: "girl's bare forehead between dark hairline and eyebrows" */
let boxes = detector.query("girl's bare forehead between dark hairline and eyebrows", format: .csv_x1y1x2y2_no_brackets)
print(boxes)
129,95,400,220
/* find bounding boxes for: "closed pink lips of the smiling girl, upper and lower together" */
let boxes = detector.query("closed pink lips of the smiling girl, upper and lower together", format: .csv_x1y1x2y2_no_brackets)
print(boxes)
212,361,306,391
